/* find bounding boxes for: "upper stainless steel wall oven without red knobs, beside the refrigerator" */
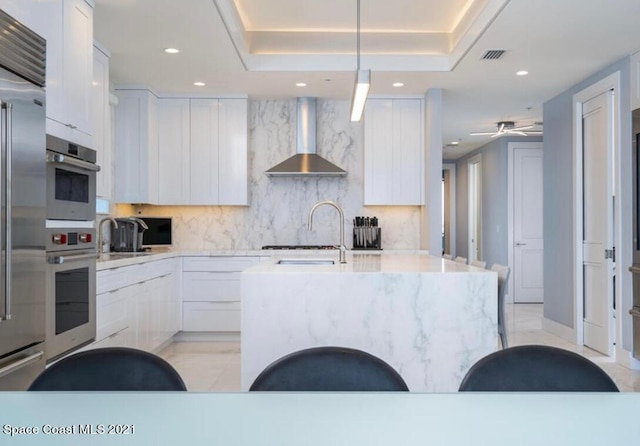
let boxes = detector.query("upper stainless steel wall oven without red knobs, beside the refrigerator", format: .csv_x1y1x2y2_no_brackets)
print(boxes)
47,135,100,221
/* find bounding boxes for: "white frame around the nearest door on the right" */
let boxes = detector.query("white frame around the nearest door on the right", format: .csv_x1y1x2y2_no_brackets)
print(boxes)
573,71,622,348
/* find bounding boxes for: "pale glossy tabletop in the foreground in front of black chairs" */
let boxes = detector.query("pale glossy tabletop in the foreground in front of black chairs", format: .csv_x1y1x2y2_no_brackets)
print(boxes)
0,392,640,446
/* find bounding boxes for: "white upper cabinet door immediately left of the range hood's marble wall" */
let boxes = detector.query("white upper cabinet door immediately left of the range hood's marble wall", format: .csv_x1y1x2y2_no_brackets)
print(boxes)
218,99,249,205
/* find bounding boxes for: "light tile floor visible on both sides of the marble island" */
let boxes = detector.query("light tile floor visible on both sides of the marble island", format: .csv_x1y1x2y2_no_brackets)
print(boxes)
159,304,640,392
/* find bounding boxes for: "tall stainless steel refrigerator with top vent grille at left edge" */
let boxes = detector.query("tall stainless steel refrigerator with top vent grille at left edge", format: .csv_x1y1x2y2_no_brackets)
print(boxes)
0,11,46,390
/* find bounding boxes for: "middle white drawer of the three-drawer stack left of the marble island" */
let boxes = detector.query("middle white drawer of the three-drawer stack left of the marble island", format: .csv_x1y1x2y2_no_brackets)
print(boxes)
182,272,240,302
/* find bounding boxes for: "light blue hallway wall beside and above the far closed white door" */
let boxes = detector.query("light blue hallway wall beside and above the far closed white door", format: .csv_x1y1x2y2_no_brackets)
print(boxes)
445,136,542,267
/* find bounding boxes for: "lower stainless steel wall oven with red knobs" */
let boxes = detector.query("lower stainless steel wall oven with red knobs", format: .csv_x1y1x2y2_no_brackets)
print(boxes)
46,226,97,362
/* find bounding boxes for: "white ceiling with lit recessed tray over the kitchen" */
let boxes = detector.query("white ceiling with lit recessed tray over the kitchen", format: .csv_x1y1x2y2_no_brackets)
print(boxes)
94,0,640,159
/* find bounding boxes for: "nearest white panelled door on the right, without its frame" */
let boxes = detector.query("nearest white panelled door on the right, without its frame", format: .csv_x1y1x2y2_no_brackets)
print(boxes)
582,91,614,355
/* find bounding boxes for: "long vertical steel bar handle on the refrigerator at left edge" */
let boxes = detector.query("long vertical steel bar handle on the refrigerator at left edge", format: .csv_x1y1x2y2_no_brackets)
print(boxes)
0,101,12,321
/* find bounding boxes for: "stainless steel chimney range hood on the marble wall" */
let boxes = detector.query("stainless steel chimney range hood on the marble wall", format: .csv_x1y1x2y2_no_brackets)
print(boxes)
265,98,347,177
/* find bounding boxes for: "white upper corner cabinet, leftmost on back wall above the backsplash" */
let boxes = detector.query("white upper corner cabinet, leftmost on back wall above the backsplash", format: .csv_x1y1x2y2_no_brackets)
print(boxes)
114,90,158,204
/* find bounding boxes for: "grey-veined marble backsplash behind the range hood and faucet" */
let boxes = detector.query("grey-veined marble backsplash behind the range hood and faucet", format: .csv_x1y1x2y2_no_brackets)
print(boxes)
115,99,420,250
